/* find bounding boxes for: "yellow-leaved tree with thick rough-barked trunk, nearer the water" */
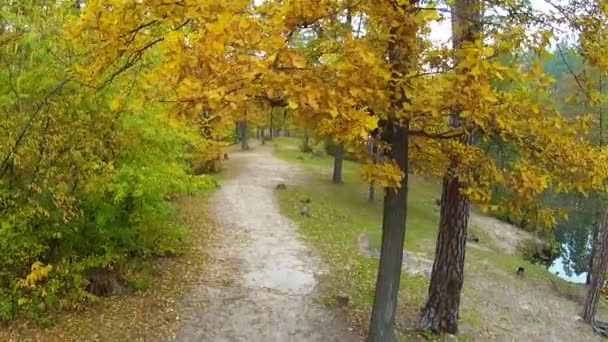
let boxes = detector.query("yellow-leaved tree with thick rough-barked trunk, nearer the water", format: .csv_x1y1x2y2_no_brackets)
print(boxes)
412,1,605,333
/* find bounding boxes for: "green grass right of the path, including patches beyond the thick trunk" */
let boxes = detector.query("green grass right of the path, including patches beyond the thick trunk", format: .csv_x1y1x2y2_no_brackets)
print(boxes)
271,138,604,340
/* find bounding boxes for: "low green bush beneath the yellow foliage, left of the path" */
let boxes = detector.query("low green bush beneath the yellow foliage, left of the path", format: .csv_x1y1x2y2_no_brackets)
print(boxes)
0,108,213,326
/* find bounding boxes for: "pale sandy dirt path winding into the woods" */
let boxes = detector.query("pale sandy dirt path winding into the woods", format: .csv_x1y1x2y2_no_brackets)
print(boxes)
176,148,359,342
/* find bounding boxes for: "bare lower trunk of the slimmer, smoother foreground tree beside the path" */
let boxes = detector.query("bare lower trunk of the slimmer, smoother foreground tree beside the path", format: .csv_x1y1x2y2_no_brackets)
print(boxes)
368,123,409,342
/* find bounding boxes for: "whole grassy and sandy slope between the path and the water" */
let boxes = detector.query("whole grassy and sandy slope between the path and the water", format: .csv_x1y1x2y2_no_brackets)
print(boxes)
273,139,603,341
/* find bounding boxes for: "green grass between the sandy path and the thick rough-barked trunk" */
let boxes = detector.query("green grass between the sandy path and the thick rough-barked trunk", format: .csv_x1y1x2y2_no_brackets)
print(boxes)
272,138,452,338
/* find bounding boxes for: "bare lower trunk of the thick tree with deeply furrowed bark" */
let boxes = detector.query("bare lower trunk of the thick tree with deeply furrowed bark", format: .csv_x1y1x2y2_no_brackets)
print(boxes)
419,172,469,334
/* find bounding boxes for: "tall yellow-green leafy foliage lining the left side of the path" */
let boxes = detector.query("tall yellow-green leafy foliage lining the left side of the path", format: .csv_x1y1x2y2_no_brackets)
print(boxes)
0,1,212,325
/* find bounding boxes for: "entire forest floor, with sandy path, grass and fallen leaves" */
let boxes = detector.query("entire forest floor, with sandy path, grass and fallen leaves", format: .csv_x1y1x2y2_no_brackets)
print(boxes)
0,138,606,342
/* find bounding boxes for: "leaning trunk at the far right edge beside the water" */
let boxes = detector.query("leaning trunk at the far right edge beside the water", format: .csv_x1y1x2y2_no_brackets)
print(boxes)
582,209,608,324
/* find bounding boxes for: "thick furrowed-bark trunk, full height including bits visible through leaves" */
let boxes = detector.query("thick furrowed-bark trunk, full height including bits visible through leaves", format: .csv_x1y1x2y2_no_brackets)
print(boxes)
419,0,481,334
